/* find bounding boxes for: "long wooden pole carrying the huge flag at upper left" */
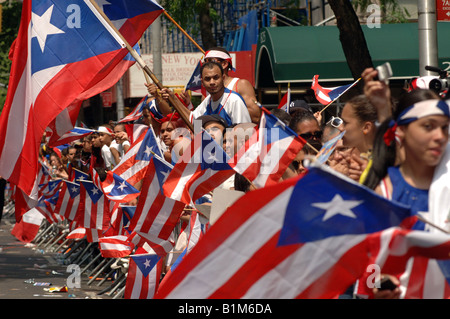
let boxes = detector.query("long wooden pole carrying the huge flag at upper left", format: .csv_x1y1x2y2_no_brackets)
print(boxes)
90,0,194,132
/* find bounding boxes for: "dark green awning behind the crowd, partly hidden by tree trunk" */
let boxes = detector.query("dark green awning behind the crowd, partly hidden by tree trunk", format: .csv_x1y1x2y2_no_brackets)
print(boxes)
255,22,450,88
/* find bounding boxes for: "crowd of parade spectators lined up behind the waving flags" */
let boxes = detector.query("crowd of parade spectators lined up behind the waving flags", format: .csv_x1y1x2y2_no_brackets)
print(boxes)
4,48,450,298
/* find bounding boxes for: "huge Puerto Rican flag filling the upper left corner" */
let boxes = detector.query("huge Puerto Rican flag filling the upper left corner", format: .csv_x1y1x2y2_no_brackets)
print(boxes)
0,0,163,199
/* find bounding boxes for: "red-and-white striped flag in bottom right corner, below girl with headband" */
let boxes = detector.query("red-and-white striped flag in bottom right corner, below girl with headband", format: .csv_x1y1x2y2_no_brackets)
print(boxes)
355,227,450,299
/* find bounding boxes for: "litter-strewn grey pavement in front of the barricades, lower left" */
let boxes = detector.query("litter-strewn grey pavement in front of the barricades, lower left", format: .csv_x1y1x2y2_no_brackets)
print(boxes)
0,218,118,299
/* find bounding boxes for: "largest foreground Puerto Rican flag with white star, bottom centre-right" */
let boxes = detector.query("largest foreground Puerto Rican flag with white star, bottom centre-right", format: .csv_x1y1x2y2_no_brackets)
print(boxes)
155,167,411,299
